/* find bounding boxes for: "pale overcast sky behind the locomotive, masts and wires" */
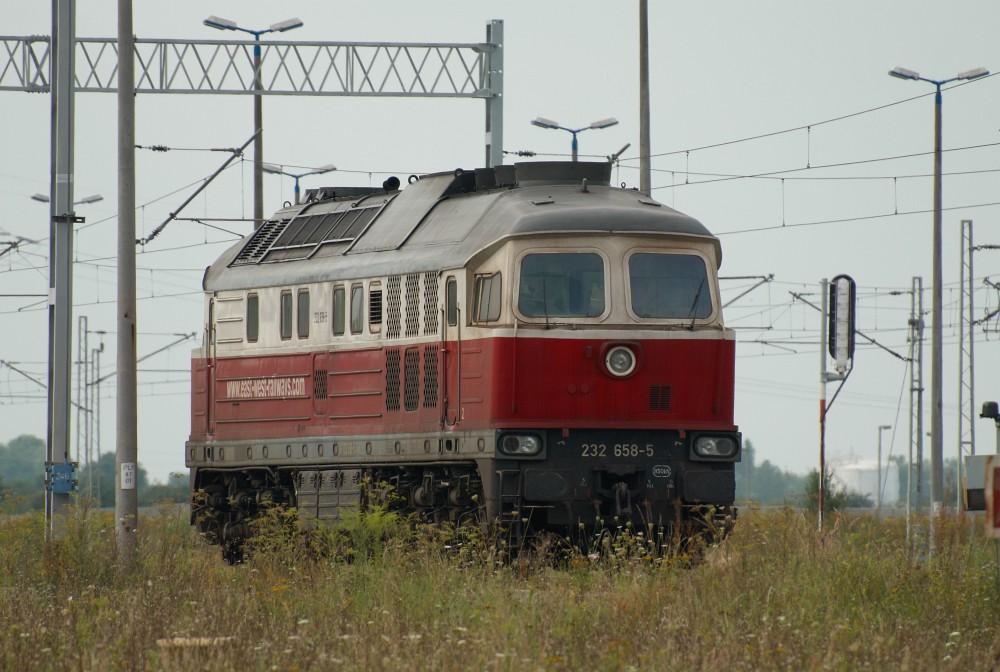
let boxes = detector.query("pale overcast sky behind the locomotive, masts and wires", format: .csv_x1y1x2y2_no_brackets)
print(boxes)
0,0,1000,480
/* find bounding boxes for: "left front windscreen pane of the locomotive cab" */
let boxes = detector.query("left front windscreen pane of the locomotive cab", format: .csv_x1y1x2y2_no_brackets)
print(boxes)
517,252,605,317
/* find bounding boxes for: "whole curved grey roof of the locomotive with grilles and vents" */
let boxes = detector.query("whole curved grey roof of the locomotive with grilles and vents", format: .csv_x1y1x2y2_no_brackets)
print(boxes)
203,162,721,291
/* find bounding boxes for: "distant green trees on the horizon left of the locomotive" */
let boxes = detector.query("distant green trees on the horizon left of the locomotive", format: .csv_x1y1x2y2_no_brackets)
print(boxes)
0,434,188,513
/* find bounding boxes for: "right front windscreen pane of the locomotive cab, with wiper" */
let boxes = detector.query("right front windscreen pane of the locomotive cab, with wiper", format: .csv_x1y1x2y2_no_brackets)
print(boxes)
628,252,712,320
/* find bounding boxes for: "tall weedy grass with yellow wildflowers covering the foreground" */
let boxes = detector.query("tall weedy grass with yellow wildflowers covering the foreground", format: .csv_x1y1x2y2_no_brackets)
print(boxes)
0,502,1000,670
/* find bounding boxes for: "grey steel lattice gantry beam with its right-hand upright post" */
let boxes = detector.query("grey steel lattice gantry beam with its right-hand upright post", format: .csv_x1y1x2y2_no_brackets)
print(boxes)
0,25,503,166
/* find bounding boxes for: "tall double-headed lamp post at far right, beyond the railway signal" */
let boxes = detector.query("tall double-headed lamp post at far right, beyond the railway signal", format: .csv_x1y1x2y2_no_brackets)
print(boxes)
889,67,990,555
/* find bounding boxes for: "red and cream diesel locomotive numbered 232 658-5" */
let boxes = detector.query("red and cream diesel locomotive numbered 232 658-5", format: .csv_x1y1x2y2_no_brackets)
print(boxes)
186,162,740,549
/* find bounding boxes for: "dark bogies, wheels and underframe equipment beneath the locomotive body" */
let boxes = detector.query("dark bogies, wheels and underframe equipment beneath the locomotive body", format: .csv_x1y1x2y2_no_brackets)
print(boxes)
191,463,736,562
